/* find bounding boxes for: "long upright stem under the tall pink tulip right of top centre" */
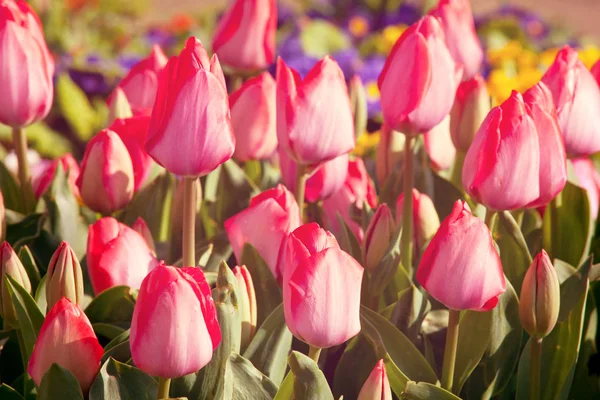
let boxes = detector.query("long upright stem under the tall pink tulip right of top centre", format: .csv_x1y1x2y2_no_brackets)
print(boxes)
402,135,414,274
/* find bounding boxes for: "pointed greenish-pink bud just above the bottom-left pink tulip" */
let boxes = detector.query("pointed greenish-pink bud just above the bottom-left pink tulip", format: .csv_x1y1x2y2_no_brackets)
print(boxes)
46,242,83,310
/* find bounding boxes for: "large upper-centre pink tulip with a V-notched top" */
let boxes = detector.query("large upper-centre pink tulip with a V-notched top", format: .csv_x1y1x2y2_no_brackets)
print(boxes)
277,56,355,165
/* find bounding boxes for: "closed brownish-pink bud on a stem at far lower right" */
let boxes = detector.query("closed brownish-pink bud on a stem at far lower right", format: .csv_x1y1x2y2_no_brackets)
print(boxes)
519,250,560,339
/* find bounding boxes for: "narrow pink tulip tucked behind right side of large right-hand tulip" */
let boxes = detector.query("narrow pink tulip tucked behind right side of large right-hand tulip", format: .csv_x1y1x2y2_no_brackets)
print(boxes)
523,82,567,207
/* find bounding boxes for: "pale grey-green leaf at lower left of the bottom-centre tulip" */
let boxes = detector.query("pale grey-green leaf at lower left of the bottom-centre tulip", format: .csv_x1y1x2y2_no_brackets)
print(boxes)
244,304,292,385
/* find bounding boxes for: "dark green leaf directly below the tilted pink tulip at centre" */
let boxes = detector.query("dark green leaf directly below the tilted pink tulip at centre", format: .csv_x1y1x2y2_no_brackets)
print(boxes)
238,243,283,327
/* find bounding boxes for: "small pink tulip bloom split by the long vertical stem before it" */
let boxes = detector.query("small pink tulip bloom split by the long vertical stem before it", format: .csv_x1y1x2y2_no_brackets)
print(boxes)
396,189,440,254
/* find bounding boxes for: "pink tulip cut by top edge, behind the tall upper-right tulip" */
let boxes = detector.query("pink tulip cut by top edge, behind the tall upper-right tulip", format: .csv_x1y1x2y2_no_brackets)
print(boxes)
429,0,483,80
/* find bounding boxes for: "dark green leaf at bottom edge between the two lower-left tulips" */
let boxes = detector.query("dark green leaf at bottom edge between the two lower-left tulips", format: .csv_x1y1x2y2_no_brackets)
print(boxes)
90,357,158,400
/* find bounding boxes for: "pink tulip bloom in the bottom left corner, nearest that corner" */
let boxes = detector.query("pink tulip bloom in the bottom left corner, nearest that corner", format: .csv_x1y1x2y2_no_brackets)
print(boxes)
27,297,104,393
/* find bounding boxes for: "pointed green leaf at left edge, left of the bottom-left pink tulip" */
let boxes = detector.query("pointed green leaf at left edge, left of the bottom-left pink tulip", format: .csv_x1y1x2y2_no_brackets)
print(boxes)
4,274,44,361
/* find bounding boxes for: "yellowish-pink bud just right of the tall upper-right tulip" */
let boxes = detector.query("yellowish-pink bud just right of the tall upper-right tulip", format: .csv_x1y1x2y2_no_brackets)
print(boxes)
450,75,492,153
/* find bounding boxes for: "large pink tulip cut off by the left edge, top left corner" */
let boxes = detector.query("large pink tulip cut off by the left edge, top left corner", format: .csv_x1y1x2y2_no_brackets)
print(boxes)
0,0,54,127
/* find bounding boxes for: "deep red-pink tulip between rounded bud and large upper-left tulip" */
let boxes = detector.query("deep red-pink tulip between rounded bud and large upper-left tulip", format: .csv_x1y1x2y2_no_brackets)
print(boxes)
109,116,152,191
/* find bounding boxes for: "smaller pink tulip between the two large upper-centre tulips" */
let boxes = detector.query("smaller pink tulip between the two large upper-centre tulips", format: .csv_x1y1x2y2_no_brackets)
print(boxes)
229,72,277,162
